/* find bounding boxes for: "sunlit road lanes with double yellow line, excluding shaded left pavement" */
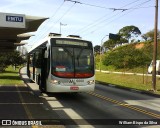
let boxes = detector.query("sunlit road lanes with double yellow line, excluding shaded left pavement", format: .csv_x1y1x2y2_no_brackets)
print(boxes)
44,84,160,128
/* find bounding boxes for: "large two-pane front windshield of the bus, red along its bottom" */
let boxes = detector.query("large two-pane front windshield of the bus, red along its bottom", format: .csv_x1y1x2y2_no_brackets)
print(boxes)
51,47,94,78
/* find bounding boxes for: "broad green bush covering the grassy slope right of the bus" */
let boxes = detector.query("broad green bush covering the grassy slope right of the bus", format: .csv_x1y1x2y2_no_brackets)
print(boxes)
103,44,151,69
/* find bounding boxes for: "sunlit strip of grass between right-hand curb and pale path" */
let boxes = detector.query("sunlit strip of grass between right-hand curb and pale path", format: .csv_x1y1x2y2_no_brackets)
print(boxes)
96,72,160,94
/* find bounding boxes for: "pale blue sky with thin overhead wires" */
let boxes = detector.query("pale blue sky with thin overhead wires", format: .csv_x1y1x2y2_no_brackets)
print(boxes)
0,0,160,48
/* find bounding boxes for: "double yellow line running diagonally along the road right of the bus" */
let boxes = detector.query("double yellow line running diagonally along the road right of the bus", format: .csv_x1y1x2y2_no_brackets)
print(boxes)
87,92,160,119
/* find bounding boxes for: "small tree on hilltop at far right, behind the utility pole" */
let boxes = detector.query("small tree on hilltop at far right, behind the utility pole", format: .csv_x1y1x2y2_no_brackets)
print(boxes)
142,29,160,41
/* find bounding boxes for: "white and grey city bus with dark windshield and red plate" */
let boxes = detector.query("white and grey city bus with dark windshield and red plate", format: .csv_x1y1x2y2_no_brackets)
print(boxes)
27,33,95,93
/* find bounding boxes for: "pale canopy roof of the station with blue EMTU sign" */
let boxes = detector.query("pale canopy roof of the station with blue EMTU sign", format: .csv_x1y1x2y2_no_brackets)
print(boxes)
0,13,48,52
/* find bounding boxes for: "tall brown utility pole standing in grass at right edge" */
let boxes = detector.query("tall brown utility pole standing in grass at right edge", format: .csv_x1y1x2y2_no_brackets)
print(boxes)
152,0,158,92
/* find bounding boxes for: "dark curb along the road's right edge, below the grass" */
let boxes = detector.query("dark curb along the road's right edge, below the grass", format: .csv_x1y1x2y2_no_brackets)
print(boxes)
96,80,160,98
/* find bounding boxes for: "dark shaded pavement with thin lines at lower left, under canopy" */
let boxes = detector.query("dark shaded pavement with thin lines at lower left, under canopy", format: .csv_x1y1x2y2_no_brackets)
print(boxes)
0,85,64,127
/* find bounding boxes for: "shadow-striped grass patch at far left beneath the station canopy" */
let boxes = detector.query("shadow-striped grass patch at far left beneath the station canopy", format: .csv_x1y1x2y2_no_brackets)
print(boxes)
0,66,23,85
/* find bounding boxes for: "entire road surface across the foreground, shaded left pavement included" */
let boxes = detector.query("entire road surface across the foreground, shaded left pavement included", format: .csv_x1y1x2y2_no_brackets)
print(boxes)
0,67,160,128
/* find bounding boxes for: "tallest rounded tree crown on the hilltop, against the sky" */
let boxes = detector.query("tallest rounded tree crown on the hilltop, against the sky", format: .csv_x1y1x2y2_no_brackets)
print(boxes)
118,25,141,41
